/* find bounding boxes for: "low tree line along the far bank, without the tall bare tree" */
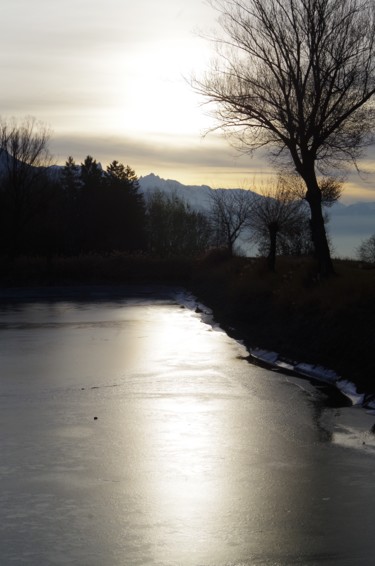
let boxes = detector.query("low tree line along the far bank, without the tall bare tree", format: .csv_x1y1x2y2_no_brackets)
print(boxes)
0,119,374,270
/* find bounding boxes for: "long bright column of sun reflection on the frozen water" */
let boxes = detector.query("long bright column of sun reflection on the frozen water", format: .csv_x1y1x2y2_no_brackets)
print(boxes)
133,307,250,561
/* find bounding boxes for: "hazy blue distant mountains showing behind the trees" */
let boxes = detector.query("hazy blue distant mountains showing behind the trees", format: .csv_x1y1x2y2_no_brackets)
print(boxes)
139,173,375,258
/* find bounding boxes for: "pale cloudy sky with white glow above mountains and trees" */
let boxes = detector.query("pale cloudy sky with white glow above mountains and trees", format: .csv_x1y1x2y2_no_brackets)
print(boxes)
0,0,375,203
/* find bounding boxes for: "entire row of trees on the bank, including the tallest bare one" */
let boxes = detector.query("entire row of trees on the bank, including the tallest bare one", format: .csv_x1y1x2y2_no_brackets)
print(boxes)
0,0,375,276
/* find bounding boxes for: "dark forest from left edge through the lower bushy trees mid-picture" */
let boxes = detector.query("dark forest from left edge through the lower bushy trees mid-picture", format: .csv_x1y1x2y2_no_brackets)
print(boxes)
0,148,223,259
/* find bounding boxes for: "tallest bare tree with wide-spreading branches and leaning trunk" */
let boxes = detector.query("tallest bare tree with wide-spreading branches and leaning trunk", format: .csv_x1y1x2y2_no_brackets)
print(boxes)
194,0,375,276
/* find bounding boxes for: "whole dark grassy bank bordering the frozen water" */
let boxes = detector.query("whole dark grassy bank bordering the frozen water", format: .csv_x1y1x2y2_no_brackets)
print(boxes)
0,251,375,394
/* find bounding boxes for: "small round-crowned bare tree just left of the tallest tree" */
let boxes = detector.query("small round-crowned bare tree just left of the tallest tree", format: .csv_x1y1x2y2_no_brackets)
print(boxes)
248,179,309,271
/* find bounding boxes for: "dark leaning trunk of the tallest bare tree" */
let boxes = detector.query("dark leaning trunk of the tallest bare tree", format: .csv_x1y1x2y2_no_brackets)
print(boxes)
302,166,335,277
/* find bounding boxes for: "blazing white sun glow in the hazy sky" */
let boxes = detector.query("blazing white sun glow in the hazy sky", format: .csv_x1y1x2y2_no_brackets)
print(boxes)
104,41,214,136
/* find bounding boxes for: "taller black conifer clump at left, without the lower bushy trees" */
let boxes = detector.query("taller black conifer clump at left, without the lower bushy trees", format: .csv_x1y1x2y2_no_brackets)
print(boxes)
0,156,147,257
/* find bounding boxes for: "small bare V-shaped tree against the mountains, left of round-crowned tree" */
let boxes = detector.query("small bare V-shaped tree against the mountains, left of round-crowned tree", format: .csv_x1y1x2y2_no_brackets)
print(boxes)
209,189,254,255
